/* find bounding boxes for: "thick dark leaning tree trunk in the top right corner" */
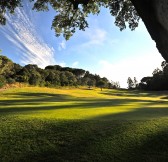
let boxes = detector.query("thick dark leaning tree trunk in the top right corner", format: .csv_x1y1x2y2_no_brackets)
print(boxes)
131,0,168,61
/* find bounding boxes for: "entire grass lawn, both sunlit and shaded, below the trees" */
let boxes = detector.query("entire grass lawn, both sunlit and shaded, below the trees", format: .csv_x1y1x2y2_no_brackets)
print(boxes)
0,87,168,162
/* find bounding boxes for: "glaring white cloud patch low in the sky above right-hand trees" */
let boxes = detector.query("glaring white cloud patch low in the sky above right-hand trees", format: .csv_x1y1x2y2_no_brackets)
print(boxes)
99,48,163,88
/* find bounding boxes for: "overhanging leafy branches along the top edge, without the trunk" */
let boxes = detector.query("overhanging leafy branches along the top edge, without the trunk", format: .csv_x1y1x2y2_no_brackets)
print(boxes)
0,0,140,40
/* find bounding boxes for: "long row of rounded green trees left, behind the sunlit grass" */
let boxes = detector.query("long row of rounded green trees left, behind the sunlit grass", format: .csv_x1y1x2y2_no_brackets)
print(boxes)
0,55,120,88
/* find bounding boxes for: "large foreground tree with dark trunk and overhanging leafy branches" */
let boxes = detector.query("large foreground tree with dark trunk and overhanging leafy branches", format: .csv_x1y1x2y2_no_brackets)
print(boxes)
0,0,168,60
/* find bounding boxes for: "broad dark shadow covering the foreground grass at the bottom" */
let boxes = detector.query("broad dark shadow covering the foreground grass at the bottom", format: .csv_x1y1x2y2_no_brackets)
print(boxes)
0,117,168,162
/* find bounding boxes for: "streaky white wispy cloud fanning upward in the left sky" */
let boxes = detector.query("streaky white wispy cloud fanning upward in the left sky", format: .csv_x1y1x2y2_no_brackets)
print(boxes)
1,3,56,68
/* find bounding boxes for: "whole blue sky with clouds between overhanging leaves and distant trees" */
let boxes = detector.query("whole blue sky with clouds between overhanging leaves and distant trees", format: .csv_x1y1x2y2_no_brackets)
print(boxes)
0,3,163,87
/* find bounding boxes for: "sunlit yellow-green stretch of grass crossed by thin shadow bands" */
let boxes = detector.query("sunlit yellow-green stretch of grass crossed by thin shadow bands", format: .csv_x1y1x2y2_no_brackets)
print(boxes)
0,87,167,120
